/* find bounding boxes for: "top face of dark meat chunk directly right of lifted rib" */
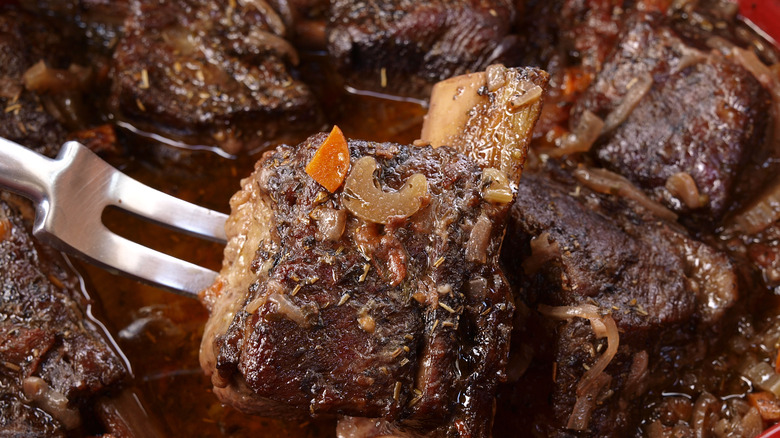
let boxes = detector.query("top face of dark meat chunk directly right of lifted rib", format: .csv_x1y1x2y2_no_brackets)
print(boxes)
509,169,736,330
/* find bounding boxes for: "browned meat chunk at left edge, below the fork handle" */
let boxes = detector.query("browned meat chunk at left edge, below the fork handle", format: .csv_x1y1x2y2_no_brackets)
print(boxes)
0,194,126,436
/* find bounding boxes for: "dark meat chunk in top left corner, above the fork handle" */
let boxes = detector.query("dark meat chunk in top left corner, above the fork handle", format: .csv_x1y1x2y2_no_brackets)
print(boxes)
0,5,113,156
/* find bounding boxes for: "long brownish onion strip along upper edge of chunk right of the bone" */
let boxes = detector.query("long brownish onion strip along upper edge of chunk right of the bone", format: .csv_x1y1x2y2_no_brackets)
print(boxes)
574,167,677,222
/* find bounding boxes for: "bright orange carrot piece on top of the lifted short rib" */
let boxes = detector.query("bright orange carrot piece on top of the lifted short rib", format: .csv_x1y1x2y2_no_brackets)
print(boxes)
306,126,349,193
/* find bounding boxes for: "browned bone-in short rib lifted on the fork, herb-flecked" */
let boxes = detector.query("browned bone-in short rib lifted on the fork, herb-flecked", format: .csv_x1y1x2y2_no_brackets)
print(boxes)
201,66,546,436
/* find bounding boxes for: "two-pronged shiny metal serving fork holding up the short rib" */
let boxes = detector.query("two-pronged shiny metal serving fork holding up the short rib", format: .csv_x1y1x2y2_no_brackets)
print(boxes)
0,138,227,296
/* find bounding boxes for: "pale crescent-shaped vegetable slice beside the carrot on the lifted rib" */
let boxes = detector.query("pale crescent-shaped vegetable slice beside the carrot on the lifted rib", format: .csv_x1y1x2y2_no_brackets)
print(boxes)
344,157,428,224
